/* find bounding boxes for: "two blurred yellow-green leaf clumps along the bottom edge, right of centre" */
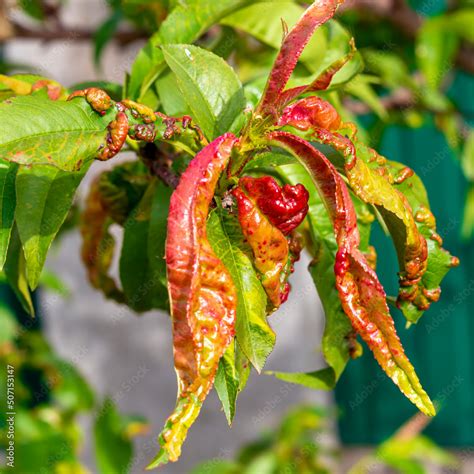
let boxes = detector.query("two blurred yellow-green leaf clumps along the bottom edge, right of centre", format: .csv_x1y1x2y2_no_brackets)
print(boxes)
191,405,457,474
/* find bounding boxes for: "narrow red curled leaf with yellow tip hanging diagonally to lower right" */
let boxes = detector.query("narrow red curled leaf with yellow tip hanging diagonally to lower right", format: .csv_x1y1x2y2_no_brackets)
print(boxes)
268,132,435,415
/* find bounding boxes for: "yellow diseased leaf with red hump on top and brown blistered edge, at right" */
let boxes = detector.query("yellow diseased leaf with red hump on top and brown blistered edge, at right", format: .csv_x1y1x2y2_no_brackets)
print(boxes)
279,97,448,322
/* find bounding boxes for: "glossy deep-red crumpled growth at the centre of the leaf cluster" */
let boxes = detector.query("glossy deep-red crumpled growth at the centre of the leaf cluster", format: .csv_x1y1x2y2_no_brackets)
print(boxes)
239,176,309,235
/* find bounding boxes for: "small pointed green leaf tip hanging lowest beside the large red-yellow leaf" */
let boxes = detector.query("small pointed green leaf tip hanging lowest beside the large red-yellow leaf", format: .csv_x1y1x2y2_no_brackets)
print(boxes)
214,343,239,425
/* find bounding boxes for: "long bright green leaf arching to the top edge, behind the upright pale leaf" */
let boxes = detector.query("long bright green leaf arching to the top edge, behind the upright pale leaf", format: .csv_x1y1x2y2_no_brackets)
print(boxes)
128,0,260,102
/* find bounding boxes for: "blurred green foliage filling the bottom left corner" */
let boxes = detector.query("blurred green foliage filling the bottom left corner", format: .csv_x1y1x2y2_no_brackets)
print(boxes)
0,294,146,474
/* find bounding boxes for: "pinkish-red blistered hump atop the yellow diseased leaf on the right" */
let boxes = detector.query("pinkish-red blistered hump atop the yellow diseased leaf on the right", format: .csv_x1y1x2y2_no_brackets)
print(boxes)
278,96,341,131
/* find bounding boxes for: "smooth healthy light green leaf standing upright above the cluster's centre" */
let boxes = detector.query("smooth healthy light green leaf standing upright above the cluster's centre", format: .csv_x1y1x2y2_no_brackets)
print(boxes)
162,45,245,139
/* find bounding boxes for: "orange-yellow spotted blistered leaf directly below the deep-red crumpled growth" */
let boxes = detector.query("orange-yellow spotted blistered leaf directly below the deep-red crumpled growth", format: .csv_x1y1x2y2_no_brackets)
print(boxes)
232,187,290,308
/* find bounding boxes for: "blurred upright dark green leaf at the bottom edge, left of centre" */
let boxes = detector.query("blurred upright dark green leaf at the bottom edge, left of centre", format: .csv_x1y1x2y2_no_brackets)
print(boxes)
94,399,133,474
